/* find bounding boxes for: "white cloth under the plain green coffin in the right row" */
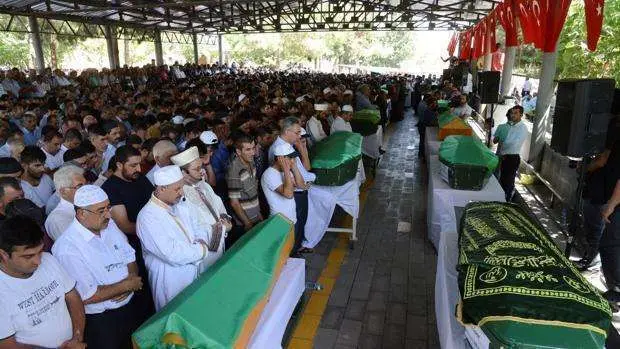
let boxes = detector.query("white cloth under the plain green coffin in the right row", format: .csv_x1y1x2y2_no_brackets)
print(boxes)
426,155,505,247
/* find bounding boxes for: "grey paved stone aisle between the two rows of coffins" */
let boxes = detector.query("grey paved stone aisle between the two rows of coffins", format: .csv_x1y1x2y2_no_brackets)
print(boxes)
307,113,439,349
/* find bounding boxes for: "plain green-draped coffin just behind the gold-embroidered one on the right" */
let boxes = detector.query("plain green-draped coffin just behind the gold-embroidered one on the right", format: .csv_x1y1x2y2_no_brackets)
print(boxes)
439,135,499,190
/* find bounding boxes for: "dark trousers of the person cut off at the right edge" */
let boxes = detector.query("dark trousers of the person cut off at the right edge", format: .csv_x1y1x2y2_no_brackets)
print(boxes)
599,207,620,292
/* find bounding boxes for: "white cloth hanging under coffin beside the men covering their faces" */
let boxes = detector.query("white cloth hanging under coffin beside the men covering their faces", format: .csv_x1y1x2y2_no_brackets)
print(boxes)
302,178,360,248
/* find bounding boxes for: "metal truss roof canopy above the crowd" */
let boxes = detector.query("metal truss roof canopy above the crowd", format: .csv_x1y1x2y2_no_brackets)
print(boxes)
0,0,494,35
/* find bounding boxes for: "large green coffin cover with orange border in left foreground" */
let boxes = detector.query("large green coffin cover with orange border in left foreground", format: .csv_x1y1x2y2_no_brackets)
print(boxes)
132,214,294,349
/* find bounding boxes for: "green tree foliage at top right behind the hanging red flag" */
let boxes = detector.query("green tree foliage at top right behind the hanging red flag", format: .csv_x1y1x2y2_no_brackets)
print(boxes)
558,0,620,81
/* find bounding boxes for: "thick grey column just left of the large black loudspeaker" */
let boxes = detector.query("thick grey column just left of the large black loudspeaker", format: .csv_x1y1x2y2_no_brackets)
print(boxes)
529,50,558,170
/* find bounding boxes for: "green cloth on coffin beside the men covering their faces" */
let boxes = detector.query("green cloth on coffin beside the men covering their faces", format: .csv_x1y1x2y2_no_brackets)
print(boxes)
310,132,362,186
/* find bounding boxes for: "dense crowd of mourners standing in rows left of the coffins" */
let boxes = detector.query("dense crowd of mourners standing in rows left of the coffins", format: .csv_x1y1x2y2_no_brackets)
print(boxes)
0,64,422,349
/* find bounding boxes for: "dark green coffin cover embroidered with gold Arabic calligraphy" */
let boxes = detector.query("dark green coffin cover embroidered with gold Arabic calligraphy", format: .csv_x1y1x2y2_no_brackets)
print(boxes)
456,202,611,349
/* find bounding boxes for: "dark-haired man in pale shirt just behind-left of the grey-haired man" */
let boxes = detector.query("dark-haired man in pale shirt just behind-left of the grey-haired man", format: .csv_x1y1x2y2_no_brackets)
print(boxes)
21,146,54,207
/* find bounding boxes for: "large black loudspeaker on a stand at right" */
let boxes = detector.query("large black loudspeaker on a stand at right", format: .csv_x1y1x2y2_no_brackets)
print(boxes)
551,79,616,157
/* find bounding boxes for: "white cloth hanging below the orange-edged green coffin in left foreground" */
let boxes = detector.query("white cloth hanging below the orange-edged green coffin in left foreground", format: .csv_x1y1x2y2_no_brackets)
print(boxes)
248,258,306,349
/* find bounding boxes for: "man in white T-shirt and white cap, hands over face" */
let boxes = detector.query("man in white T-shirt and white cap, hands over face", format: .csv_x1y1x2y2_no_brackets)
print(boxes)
261,143,308,253
